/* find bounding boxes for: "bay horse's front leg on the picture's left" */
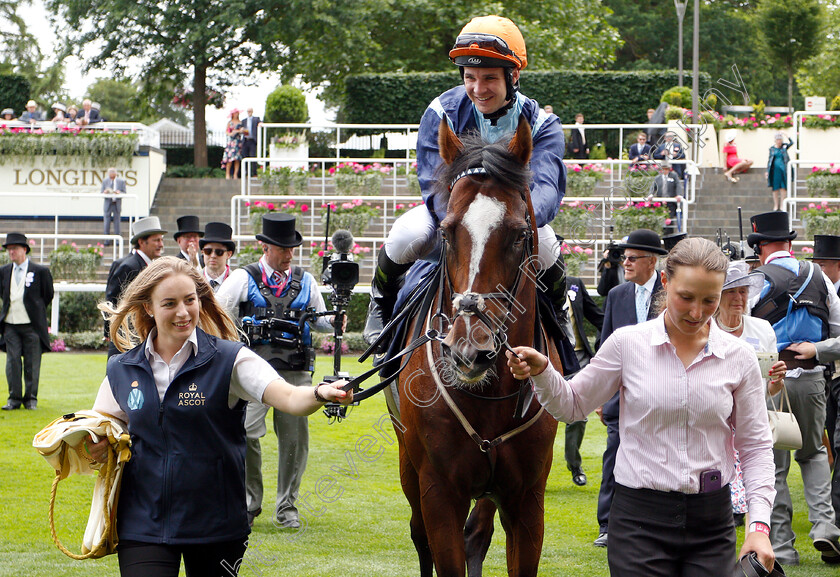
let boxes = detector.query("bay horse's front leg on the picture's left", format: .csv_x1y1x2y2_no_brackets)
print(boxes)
420,467,471,577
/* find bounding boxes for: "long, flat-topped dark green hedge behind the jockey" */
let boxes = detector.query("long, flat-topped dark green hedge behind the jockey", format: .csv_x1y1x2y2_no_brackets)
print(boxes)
343,70,711,124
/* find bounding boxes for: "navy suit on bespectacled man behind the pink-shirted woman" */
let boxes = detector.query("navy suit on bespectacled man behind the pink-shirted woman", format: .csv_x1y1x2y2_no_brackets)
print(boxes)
598,271,662,533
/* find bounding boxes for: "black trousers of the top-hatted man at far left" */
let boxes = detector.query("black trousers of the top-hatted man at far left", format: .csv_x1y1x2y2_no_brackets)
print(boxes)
3,323,42,405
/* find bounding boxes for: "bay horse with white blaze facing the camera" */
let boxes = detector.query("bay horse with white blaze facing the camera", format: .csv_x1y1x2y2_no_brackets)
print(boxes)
392,118,560,577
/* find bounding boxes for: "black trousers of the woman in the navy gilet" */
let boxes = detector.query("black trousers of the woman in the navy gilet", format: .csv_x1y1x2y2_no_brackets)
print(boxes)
117,537,248,577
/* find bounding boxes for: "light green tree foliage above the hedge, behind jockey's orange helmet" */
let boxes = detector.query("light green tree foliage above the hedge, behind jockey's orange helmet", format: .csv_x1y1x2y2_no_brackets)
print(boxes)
265,0,620,105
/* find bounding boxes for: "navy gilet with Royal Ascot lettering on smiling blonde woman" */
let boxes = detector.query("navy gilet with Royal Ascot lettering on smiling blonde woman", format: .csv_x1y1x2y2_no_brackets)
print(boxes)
108,329,250,544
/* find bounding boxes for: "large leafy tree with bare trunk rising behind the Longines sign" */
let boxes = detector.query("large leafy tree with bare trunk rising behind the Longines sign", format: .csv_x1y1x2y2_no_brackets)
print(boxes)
47,0,278,167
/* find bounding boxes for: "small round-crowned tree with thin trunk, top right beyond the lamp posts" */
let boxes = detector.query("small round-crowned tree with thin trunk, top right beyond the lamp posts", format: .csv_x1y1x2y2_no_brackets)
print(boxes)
756,0,822,107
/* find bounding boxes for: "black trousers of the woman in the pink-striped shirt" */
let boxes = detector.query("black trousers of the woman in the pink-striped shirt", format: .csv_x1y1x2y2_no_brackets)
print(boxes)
607,483,736,577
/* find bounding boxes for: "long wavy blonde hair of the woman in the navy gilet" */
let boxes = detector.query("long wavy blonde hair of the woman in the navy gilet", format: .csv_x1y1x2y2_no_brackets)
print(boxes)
98,256,239,351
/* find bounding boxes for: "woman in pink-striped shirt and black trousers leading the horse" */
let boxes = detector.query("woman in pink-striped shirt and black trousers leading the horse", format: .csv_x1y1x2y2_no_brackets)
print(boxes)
507,238,775,577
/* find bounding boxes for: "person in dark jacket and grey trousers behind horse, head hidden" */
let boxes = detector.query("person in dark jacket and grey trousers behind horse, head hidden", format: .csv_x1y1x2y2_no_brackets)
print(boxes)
564,276,604,487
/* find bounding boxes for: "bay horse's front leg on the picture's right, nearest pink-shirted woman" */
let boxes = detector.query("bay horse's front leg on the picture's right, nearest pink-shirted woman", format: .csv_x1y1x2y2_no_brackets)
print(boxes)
499,479,545,577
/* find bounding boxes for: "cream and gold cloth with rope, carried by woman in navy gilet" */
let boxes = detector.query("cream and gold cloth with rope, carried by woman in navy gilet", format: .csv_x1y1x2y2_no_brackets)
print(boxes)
32,411,131,559
